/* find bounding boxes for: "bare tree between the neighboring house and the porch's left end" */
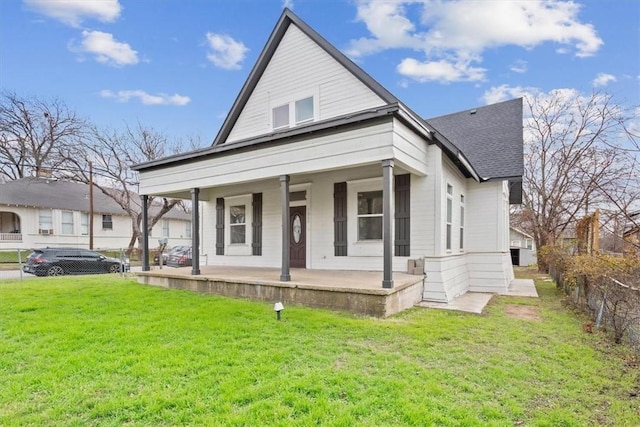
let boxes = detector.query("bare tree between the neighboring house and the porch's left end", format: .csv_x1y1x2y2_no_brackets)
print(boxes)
65,123,198,249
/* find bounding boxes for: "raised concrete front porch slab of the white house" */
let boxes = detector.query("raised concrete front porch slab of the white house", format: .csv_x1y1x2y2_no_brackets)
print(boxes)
137,266,424,317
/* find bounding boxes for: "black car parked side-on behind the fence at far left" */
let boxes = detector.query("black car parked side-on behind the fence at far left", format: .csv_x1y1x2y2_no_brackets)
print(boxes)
22,248,131,276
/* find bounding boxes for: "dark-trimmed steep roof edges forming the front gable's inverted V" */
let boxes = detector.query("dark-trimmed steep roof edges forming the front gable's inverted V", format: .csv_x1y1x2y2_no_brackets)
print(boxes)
212,8,399,147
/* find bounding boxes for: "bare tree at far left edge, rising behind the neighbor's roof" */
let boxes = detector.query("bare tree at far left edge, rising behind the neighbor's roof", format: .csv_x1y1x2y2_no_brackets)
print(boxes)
0,92,86,180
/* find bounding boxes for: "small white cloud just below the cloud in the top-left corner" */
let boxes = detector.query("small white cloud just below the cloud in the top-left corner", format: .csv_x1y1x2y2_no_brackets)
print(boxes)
69,30,138,67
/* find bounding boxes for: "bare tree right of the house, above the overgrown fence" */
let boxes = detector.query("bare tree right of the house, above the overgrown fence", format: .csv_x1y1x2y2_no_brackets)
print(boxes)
519,91,639,269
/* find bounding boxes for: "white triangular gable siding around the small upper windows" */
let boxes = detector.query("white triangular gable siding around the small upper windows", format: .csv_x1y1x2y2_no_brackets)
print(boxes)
226,24,384,142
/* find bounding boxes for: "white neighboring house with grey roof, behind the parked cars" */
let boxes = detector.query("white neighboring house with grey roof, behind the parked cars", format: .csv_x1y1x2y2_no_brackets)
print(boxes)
0,178,191,249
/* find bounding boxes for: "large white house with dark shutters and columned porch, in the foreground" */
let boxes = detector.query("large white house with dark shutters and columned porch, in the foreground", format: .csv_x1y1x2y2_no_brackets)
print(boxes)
134,9,523,301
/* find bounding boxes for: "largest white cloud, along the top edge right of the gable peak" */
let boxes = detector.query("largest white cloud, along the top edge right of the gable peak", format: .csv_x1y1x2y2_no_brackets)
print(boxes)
347,0,603,81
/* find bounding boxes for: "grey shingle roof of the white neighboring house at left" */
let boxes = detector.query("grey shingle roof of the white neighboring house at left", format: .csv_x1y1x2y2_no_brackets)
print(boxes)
0,177,191,220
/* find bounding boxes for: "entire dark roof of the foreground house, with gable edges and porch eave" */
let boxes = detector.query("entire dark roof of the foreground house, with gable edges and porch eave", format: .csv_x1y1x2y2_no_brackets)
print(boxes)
132,8,523,191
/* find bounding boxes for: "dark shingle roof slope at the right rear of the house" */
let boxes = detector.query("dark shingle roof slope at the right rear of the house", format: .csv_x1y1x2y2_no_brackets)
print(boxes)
426,98,524,180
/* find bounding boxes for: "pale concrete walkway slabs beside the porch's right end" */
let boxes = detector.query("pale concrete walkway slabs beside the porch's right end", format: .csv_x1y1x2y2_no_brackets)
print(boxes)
416,279,538,314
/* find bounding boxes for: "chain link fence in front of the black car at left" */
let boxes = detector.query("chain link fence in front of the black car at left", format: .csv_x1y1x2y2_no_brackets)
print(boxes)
0,247,138,280
